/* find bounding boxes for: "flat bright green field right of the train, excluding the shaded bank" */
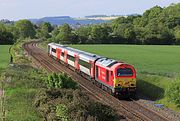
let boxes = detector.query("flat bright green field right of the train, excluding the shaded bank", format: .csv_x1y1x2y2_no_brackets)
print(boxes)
72,45,180,76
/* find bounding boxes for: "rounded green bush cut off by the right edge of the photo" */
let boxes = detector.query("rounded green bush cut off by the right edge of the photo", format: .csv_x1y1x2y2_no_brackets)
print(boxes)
166,80,180,107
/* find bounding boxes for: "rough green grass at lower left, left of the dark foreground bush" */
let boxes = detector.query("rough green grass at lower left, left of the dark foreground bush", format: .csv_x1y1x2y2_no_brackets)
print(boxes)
5,65,45,121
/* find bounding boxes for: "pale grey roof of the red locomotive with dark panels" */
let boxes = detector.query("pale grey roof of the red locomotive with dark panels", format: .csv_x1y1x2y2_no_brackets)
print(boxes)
96,58,118,68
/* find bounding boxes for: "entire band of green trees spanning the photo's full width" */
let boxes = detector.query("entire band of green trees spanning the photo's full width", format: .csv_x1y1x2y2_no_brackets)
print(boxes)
0,3,180,45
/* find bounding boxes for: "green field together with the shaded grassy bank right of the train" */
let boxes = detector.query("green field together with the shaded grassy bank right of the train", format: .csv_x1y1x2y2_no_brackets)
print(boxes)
71,45,180,110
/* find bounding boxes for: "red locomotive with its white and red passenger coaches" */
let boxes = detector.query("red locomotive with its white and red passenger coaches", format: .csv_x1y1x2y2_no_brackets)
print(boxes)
48,43,136,97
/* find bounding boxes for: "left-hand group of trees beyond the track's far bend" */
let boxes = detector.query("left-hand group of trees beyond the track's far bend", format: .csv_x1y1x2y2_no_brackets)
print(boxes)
0,20,53,44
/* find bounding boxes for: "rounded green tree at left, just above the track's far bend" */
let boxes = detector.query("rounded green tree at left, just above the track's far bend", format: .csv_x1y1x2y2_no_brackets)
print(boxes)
15,20,36,39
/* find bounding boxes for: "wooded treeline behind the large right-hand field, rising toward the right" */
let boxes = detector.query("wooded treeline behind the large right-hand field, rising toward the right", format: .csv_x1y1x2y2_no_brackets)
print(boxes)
50,3,180,45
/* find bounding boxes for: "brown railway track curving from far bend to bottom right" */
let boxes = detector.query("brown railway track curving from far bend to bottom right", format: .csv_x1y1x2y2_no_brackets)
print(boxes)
23,42,169,121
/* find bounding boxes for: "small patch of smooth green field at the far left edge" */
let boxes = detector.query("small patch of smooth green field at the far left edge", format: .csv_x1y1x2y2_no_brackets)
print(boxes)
0,45,11,70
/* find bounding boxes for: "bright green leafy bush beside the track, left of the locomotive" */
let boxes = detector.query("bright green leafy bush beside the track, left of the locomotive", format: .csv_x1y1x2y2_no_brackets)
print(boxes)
46,73,77,89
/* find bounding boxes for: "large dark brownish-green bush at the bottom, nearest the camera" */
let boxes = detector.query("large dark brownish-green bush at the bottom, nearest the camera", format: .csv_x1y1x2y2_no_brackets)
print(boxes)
35,89,119,121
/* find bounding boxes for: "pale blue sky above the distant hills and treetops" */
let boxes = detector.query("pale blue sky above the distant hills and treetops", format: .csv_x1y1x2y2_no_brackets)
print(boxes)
0,0,180,20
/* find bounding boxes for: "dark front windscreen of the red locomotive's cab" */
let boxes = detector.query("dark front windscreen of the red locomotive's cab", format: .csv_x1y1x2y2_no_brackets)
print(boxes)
117,68,133,76
